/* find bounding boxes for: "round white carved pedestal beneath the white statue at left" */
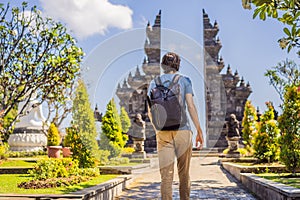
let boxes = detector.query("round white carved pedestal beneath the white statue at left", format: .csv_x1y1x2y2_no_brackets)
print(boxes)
8,128,47,152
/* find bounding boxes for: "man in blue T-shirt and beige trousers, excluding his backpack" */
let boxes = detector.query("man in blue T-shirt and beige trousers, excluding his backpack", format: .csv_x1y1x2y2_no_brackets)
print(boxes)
148,52,204,200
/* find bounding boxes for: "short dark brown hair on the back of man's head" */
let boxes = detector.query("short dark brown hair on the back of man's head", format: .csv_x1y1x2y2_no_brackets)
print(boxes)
161,52,180,73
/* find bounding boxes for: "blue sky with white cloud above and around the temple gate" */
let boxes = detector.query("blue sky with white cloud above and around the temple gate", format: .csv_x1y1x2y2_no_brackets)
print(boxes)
2,0,298,130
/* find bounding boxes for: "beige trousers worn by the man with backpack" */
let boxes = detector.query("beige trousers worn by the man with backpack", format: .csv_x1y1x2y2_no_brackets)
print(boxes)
156,130,192,200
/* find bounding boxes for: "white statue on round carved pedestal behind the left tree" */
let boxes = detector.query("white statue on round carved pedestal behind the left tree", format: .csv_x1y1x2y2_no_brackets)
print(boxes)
8,95,48,151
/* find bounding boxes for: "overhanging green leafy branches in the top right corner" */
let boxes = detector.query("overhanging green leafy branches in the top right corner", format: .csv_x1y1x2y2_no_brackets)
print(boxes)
242,0,300,55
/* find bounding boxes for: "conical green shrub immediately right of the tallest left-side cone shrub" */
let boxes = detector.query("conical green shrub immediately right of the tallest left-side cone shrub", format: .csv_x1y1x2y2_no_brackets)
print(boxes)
100,99,128,157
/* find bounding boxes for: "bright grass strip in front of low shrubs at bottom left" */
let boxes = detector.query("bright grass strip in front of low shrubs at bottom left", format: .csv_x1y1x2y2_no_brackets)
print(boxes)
0,174,119,194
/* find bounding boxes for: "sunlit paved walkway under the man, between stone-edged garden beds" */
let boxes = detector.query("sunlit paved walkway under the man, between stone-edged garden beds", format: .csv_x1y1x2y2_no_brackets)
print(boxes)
116,157,256,200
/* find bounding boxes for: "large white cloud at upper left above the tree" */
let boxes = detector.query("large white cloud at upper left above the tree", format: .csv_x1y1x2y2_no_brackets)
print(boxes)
40,0,133,38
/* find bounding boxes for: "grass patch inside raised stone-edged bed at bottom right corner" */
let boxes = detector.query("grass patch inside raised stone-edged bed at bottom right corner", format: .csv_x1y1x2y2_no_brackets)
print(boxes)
257,173,300,189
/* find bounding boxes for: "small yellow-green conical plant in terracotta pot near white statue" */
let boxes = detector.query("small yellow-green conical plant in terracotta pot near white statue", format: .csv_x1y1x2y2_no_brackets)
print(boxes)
47,123,62,158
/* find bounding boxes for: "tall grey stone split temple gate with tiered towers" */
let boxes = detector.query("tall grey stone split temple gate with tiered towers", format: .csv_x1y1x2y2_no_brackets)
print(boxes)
116,10,251,152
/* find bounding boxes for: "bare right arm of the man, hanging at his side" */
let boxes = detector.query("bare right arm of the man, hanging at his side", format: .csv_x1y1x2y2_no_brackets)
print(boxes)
185,93,204,149
